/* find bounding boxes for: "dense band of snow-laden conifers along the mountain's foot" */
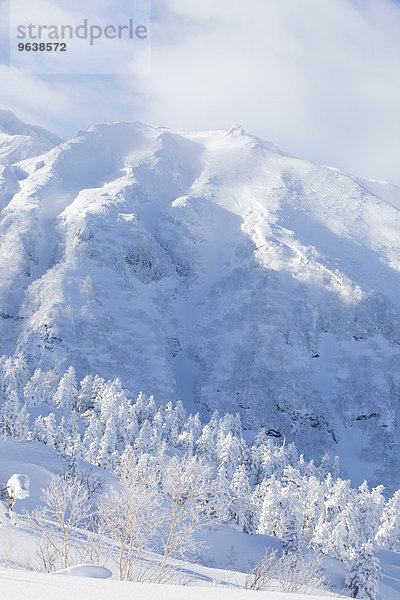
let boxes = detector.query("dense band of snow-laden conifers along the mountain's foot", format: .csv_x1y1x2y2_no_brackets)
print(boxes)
0,357,400,590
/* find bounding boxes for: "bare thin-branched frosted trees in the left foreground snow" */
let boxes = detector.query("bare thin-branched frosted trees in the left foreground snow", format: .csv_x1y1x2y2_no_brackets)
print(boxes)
27,453,213,583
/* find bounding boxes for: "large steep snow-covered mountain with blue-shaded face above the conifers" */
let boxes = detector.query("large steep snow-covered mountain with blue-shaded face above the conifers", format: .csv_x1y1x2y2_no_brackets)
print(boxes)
0,113,400,487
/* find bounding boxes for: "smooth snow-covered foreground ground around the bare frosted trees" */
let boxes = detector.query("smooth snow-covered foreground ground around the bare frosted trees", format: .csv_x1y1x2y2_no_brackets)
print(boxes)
0,439,400,600
